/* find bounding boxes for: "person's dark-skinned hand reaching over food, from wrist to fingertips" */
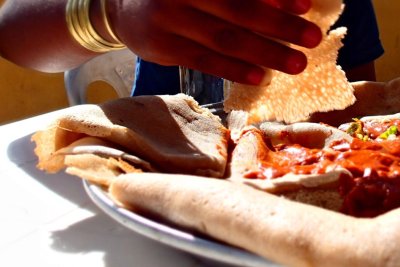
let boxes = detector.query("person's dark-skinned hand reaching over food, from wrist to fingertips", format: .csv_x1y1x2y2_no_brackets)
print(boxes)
109,0,322,85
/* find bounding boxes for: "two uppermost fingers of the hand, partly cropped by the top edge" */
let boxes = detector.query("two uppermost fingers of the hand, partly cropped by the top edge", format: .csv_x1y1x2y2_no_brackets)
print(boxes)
194,0,322,48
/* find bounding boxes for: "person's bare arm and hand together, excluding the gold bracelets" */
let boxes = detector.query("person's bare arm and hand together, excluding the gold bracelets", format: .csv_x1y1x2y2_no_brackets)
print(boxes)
0,0,322,84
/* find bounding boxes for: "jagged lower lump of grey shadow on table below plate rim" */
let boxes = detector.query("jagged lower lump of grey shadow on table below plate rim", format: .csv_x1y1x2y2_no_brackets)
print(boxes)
48,213,206,267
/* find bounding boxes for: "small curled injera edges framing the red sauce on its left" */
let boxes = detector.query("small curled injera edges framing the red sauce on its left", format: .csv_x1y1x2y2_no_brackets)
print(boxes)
228,122,352,194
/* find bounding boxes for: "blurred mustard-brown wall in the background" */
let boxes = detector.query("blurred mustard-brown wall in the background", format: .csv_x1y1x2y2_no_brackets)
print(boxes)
0,0,400,124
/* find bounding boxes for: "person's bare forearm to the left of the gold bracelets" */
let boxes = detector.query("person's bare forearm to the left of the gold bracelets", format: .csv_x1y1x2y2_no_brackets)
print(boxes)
0,0,101,72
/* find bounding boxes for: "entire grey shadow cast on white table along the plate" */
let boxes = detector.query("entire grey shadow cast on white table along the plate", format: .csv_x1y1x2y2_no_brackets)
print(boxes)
7,135,247,267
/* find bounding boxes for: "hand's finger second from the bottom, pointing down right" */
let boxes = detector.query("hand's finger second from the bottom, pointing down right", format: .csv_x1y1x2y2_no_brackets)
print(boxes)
158,5,307,74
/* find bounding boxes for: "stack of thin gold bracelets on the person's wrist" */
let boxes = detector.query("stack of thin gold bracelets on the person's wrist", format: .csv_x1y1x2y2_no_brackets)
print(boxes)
66,0,125,53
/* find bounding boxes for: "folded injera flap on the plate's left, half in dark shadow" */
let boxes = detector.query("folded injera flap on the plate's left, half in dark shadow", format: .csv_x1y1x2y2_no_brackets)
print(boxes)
33,94,229,177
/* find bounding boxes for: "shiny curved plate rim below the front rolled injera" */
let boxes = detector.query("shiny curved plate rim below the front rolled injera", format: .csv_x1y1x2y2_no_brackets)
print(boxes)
83,180,278,267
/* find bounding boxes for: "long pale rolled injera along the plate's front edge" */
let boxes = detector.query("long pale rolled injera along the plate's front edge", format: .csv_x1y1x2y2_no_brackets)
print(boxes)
110,173,400,267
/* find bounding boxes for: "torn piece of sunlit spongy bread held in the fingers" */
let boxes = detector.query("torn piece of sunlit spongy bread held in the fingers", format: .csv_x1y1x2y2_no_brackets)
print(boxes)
224,0,355,123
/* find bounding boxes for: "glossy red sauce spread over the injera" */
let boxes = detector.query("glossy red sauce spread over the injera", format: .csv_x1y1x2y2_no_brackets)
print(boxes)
238,120,400,217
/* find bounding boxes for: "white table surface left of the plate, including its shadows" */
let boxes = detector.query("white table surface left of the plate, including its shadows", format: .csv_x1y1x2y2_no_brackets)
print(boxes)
0,111,241,267
